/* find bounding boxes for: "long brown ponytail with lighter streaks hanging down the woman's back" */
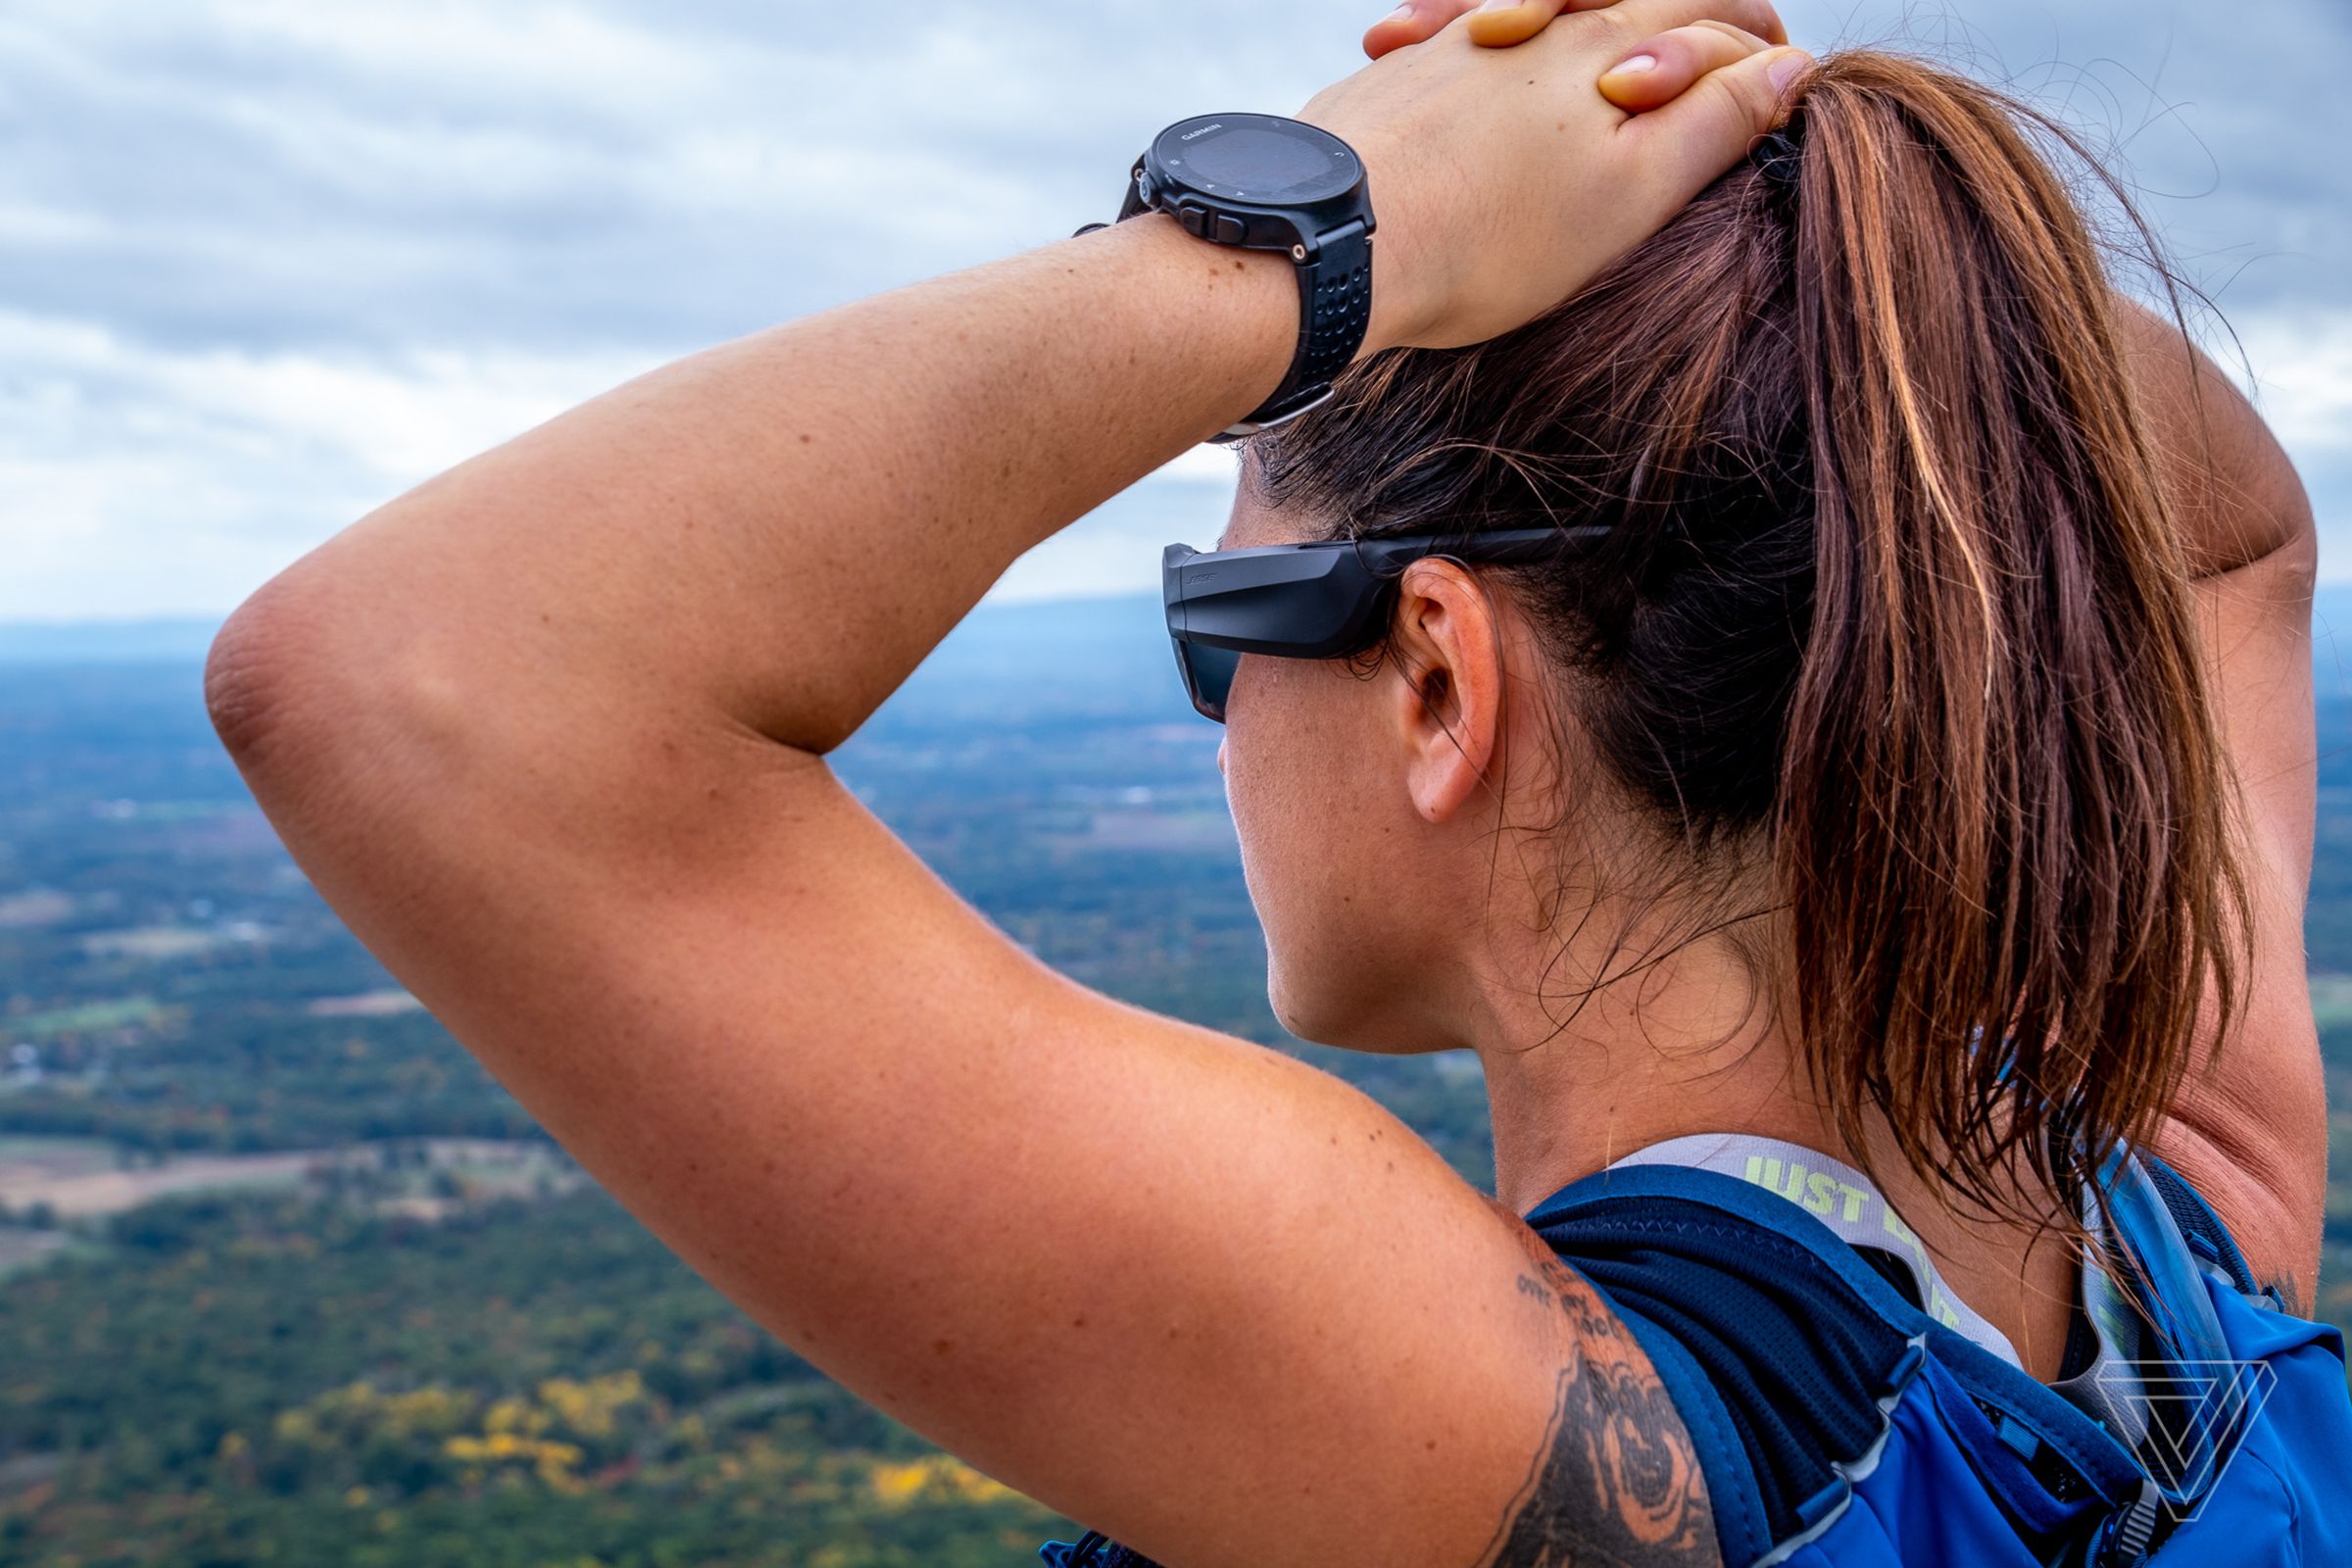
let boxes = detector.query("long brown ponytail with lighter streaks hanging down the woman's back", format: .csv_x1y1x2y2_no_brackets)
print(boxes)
1771,54,2244,1199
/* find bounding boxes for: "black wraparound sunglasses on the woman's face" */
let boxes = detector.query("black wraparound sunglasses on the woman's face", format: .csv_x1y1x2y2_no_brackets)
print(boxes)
1159,524,1611,724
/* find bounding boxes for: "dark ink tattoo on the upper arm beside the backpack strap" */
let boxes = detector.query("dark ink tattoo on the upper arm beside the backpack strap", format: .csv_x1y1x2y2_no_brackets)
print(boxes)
1480,1199,1722,1568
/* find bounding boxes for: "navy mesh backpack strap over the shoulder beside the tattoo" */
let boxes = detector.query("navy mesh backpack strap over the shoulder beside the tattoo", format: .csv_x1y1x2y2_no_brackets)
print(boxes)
1527,1166,2142,1566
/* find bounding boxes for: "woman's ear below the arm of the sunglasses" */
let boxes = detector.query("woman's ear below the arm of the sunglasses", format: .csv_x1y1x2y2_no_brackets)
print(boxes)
1388,558,1505,823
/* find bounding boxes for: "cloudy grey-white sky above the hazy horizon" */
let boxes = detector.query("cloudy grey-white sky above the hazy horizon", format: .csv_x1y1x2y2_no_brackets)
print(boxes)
0,0,2352,620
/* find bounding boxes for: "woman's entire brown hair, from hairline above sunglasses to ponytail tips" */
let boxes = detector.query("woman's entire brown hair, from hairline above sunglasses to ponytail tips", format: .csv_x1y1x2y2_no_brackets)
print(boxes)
1247,52,2246,1210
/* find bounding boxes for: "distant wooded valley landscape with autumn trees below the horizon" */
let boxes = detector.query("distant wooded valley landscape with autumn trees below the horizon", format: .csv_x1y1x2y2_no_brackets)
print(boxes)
0,588,2352,1568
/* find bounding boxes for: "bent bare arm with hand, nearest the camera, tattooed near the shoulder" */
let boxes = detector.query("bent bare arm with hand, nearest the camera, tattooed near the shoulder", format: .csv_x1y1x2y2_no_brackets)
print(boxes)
210,0,1771,1568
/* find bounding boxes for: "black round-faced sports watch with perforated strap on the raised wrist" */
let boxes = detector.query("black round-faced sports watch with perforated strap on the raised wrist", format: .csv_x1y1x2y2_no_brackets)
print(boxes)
1077,116,1374,444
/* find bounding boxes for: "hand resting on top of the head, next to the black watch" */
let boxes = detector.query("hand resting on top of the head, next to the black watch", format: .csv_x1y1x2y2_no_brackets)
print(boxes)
1298,0,1811,353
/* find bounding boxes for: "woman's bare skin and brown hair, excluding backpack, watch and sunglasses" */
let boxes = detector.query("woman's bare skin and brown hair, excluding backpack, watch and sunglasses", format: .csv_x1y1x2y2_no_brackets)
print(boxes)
210,0,2342,1566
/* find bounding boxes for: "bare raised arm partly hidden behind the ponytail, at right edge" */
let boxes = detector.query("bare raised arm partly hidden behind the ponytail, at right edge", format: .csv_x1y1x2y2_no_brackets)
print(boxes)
2124,303,2327,1309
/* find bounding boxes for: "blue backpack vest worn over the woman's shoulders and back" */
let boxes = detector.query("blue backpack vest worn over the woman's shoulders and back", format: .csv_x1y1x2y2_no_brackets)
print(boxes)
1040,1150,2352,1568
